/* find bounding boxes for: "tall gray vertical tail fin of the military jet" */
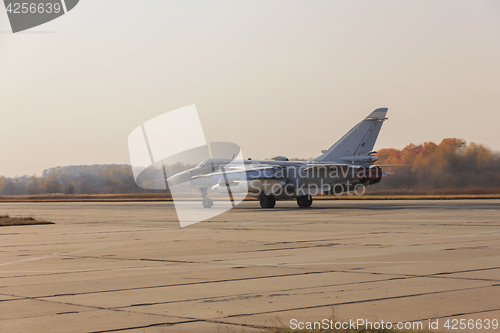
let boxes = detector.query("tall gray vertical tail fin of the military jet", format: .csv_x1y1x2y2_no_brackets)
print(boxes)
313,108,387,162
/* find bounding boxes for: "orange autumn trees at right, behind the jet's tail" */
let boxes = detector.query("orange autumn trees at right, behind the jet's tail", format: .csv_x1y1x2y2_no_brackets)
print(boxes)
374,138,500,190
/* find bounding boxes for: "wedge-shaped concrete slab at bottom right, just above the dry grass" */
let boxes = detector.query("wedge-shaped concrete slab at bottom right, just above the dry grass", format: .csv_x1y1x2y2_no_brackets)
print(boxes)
230,288,500,332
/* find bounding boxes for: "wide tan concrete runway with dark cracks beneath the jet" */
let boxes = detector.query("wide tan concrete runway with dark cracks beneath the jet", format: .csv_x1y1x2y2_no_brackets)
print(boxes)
0,200,500,332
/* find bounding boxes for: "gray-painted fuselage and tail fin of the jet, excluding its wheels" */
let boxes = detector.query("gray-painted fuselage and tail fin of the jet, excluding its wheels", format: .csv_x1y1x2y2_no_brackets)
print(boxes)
169,108,387,199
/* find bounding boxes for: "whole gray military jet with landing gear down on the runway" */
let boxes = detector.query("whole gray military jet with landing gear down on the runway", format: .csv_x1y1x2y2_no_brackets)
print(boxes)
167,108,387,208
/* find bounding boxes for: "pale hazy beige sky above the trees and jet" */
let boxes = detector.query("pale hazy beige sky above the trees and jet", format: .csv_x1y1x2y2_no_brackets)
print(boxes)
0,0,500,176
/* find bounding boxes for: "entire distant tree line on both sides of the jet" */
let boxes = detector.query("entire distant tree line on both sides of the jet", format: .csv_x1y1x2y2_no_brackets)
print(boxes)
0,139,500,195
